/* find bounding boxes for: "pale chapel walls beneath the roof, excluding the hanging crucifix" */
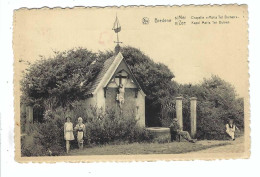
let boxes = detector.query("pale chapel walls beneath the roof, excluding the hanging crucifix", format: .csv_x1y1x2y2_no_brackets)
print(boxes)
86,57,145,126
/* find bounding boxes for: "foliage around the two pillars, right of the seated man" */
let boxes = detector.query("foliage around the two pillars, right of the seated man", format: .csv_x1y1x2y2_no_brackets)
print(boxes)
179,76,244,139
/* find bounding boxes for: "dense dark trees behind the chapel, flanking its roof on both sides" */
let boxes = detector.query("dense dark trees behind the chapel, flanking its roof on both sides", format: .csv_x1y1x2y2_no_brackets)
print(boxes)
21,46,178,126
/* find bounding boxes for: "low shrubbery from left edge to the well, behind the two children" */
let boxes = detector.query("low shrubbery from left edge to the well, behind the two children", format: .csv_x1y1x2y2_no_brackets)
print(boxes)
21,102,152,156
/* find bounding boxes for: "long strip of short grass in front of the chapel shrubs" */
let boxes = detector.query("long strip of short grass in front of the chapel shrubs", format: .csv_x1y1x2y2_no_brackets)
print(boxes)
69,141,229,156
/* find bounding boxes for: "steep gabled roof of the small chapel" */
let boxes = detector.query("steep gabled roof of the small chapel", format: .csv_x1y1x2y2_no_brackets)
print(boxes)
88,52,145,96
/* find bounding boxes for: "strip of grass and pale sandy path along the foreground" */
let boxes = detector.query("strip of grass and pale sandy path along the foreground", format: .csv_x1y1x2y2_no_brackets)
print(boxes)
69,137,244,156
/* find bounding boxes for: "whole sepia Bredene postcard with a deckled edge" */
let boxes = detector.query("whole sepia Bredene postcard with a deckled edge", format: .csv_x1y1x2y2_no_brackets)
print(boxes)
13,5,250,162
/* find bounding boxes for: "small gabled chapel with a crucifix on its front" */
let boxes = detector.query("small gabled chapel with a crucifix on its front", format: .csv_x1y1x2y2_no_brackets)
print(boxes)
86,49,146,127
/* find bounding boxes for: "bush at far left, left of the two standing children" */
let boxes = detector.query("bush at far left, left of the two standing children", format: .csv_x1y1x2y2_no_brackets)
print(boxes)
21,110,65,156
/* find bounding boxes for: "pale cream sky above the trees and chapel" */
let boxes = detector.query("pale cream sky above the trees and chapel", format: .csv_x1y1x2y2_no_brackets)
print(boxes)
13,6,249,97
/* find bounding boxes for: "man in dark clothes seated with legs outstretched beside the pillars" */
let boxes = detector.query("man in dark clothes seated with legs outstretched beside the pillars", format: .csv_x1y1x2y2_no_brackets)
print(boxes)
170,118,196,143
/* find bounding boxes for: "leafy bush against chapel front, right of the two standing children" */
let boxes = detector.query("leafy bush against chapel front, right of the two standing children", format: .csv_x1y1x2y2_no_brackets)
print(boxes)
86,110,153,144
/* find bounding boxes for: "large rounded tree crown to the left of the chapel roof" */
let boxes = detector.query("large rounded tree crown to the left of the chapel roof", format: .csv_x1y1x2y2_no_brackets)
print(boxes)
21,48,103,110
